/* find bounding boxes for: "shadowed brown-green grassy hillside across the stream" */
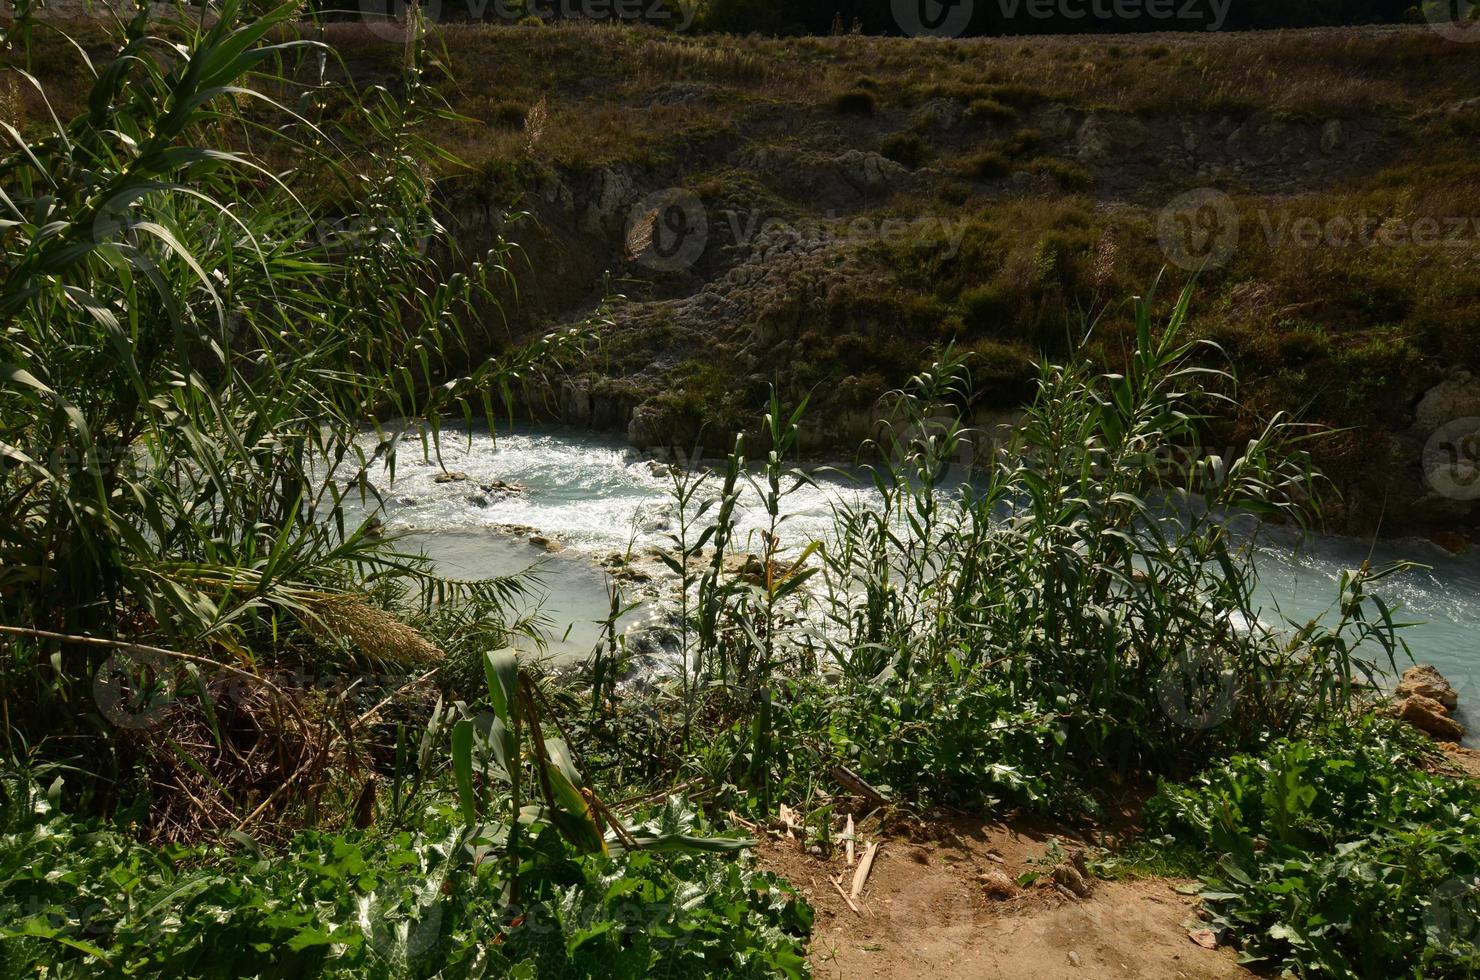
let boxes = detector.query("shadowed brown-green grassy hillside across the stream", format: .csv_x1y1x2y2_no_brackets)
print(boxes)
19,22,1480,531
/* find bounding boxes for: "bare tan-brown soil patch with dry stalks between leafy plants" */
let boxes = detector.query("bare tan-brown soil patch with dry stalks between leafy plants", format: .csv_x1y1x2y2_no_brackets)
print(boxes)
759,820,1254,980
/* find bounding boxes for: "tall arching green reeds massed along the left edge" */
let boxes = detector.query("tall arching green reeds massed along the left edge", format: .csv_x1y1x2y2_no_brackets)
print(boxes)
0,1,571,817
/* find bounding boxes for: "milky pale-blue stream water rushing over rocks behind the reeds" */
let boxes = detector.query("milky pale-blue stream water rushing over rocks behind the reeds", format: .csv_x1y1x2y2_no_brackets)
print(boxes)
361,426,1480,745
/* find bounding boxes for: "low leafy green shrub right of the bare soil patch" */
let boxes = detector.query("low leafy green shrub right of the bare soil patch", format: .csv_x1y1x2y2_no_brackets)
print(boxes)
1147,719,1480,977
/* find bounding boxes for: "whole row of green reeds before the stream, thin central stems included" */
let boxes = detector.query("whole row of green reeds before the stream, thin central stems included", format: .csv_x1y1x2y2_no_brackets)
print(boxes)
618,278,1406,807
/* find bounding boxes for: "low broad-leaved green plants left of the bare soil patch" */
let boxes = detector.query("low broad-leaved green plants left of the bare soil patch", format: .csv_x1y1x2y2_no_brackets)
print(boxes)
0,801,811,979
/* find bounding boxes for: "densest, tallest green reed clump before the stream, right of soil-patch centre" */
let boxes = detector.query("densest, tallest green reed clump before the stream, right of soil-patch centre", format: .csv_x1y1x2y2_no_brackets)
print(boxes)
827,284,1403,771
